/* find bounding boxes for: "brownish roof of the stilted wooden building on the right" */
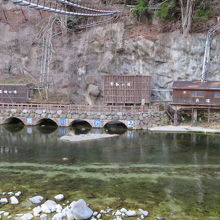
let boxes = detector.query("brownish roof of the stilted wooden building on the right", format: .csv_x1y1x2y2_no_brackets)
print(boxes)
173,80,220,90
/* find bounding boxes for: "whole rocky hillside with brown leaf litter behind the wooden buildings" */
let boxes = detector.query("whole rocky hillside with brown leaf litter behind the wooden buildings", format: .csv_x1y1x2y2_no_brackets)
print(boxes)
0,0,220,104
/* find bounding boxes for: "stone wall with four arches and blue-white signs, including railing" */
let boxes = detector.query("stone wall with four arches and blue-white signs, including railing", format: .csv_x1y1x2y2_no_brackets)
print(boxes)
0,103,168,129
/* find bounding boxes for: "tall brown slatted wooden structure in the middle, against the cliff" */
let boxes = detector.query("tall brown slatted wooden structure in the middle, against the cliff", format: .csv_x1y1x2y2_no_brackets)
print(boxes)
103,75,150,105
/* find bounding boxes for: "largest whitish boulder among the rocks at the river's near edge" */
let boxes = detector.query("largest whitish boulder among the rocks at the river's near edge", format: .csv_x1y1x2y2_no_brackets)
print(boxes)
70,199,93,220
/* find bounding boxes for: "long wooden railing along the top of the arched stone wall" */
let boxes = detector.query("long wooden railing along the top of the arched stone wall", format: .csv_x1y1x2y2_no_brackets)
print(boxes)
0,103,145,113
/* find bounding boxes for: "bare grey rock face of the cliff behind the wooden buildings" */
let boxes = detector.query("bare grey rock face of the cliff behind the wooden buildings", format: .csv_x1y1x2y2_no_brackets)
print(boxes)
0,2,220,104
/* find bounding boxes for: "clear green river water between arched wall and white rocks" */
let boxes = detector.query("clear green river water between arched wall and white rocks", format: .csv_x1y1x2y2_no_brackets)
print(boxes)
0,126,220,220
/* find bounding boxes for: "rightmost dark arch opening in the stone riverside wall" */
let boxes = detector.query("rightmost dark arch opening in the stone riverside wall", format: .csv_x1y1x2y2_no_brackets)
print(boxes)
104,120,128,134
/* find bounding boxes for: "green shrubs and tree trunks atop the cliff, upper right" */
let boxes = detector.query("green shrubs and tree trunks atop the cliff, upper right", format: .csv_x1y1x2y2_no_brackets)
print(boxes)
132,0,220,35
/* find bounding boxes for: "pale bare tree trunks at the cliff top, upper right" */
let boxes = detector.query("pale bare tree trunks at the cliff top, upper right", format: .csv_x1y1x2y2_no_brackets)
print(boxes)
179,0,196,36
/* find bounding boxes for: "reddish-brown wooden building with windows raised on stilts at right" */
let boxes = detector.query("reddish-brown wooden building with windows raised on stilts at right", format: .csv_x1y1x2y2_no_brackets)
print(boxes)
173,81,220,106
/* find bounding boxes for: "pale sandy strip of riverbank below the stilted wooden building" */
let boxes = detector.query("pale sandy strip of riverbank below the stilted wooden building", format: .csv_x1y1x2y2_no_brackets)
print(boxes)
149,125,220,133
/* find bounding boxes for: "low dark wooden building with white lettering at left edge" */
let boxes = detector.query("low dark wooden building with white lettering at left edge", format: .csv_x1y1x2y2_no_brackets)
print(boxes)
0,84,33,103
